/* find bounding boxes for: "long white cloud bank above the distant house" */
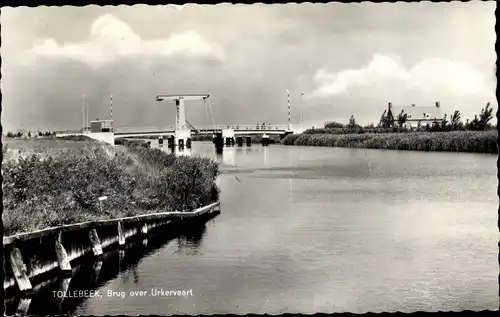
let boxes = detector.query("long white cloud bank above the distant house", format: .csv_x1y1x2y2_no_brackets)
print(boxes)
305,54,493,98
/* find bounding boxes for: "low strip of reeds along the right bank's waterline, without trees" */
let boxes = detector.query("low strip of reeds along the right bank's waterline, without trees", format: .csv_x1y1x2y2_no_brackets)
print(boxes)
283,130,498,154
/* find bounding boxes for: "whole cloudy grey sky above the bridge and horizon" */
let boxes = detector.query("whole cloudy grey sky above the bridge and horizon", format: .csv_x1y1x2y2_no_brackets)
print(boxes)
1,2,497,130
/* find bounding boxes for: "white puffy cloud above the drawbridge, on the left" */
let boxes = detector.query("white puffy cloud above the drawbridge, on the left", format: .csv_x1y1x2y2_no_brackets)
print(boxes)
24,14,224,66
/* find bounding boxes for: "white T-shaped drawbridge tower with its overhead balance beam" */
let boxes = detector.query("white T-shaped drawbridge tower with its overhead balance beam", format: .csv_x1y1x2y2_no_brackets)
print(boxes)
156,94,210,146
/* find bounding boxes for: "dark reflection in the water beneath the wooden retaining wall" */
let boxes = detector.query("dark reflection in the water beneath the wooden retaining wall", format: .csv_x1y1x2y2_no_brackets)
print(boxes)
4,218,215,316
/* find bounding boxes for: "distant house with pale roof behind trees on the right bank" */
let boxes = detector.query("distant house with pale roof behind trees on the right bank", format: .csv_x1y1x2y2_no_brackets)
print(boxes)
387,102,444,128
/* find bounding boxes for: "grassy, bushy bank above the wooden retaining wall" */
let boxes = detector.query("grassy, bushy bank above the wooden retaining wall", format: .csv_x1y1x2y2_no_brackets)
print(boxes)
2,140,219,235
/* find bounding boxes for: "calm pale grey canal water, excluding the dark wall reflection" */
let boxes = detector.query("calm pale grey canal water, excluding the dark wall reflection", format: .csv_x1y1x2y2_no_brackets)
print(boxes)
5,142,499,315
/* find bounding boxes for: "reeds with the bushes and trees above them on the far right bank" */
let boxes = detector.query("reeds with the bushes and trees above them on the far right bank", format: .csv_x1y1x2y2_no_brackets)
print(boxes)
282,103,498,154
